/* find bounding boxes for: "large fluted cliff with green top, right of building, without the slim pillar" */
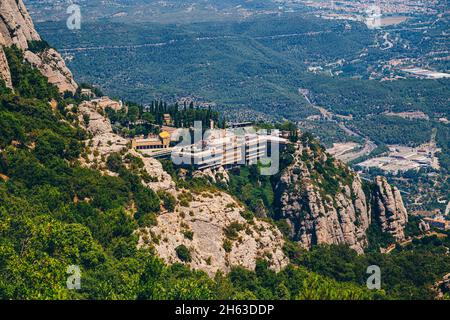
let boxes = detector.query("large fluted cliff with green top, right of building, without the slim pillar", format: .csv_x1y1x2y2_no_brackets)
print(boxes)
277,144,371,253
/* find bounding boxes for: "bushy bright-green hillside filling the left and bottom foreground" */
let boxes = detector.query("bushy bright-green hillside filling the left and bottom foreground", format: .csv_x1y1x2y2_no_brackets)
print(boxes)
0,43,384,299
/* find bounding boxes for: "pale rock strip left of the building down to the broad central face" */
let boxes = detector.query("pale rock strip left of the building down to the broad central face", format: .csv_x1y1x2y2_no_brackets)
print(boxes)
78,101,288,276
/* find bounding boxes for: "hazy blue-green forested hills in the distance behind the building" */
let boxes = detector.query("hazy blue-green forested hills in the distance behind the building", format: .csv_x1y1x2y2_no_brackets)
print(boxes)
36,18,449,120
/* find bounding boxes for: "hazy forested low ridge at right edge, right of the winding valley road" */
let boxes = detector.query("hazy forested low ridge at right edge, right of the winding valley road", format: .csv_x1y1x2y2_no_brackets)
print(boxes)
310,78,450,118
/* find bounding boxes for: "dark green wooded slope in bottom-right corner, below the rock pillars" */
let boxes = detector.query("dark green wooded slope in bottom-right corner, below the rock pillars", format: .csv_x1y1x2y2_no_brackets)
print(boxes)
286,238,450,299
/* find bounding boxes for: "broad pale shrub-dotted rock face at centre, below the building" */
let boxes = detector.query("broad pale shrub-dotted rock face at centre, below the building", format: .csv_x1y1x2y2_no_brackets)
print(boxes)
139,191,289,277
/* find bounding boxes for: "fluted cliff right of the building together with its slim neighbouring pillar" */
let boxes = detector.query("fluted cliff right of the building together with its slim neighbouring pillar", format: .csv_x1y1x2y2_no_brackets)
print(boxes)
276,142,408,254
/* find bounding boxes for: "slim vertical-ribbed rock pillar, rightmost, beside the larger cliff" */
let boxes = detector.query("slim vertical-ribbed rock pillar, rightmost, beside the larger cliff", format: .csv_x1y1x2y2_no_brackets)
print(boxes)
374,177,408,241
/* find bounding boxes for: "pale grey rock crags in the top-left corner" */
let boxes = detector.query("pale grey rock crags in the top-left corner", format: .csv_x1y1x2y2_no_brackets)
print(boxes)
0,0,77,93
